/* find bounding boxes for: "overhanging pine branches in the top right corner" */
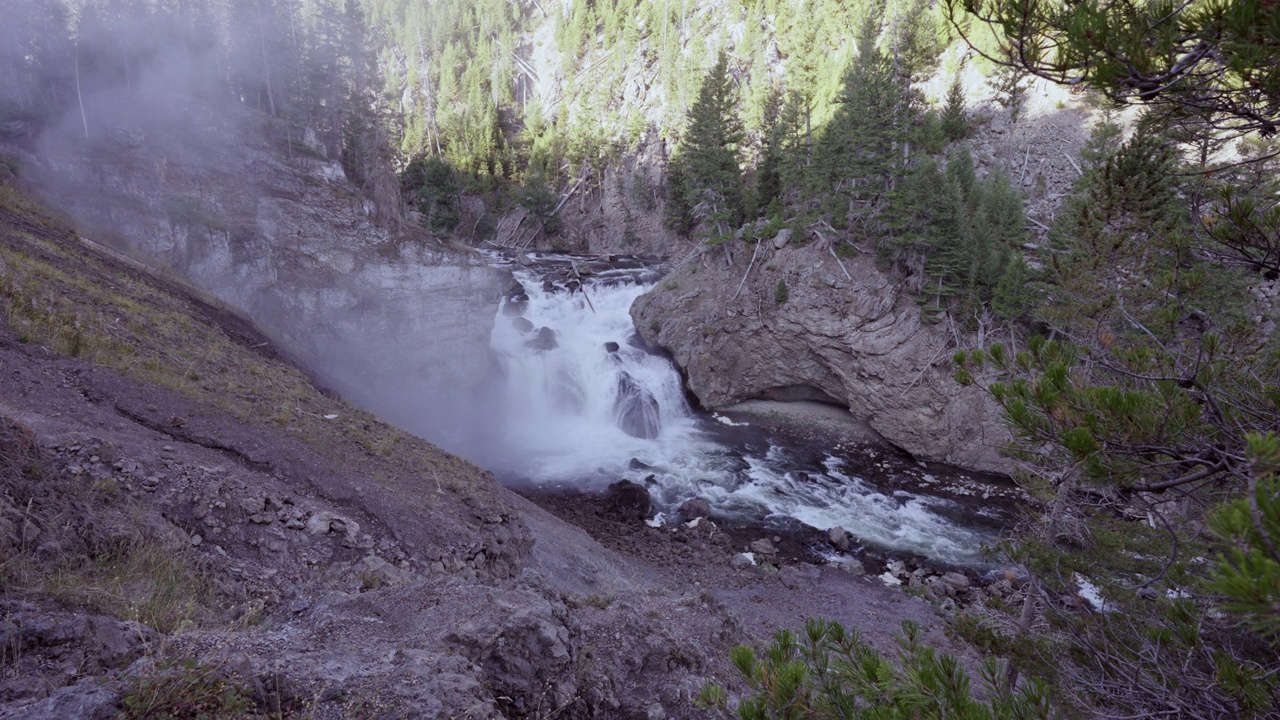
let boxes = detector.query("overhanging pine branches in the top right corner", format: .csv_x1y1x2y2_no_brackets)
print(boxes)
947,0,1280,135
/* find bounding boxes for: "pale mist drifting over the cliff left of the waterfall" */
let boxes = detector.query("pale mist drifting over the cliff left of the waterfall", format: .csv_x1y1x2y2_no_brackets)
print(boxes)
0,0,524,461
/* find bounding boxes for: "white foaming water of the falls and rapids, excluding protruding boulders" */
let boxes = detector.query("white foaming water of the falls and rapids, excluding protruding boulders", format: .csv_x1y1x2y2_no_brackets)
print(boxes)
492,258,989,564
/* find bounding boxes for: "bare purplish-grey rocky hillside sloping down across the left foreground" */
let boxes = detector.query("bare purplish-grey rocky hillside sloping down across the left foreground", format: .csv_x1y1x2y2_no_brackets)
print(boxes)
0,165,967,719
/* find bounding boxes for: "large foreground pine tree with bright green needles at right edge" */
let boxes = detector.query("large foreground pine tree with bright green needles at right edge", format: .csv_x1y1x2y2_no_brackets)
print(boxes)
957,123,1280,719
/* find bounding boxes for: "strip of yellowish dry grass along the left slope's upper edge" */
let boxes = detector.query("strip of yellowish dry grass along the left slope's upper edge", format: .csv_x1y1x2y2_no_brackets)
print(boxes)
0,175,475,502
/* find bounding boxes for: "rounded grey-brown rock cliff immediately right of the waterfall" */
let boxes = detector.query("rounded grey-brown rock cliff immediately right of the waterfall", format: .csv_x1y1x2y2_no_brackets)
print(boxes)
631,241,1007,471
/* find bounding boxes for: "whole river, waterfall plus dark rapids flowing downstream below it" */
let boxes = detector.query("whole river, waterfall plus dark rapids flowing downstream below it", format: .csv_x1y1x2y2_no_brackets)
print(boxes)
488,256,1007,565
